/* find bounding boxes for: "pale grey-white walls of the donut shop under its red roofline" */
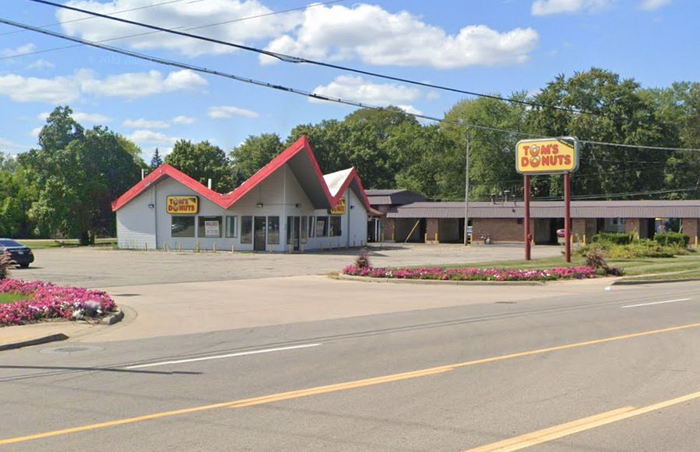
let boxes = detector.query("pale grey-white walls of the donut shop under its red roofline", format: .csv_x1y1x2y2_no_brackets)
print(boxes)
117,166,367,252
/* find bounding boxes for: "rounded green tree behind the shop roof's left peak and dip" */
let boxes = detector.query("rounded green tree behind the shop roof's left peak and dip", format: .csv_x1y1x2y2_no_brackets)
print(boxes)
165,140,234,193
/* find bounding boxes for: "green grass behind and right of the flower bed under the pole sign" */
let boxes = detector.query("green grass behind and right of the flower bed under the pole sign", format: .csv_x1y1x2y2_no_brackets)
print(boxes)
404,249,700,279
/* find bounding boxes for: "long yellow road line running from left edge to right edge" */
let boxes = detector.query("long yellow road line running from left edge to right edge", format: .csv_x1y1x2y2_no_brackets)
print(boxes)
0,322,700,446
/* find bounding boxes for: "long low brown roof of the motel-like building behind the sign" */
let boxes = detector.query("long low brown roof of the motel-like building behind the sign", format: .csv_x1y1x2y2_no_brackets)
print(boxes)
386,200,700,218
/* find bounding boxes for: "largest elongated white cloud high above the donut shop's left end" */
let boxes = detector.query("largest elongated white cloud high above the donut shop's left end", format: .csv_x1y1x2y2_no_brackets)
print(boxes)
76,69,207,99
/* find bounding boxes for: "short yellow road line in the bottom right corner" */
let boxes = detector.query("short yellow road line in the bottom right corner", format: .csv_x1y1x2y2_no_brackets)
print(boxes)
466,391,700,452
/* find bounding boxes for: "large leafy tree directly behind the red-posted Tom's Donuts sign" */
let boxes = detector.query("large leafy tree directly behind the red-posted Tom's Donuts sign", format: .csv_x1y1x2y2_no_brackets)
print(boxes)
528,68,675,195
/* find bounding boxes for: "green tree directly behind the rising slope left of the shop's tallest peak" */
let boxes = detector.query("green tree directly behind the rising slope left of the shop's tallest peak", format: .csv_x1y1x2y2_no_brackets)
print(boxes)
230,133,284,185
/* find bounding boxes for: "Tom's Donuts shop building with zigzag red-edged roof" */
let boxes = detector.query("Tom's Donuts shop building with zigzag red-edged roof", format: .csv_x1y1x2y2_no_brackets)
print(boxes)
112,136,380,252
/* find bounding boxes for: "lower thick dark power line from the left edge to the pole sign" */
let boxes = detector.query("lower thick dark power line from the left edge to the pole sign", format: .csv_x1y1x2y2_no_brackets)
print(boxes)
0,18,535,137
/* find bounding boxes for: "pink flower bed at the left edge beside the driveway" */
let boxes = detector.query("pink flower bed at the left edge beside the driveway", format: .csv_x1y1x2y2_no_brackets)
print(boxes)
0,279,117,326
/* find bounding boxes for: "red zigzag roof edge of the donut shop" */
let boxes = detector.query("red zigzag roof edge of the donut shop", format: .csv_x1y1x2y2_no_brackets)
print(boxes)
112,136,380,215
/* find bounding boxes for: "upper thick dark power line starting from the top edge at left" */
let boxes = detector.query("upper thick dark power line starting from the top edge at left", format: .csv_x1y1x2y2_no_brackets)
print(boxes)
29,0,601,116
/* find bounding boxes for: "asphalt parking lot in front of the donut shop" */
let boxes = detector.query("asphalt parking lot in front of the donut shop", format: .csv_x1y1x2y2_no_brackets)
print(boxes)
12,244,561,288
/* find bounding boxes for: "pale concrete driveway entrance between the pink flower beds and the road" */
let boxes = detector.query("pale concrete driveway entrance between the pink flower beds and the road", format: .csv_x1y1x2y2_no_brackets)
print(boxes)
78,276,611,342
